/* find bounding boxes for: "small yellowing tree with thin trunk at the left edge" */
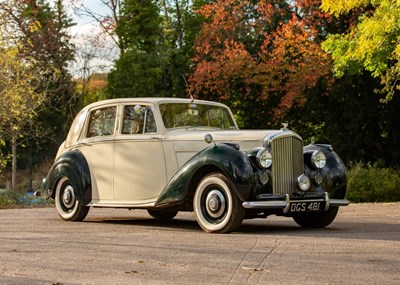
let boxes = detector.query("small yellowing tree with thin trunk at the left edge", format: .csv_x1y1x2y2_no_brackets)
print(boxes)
0,49,45,190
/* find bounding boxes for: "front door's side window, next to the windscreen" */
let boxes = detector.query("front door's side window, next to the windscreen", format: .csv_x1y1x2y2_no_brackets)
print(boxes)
122,105,157,134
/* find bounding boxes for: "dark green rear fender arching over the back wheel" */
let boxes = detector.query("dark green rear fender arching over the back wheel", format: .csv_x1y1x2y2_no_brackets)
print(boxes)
43,150,92,205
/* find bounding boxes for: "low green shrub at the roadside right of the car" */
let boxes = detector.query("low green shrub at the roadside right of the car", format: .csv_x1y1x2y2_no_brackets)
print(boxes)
347,163,400,202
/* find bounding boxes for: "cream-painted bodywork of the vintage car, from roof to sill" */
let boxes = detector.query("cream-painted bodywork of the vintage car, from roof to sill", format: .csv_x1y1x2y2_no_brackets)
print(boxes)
57,98,275,207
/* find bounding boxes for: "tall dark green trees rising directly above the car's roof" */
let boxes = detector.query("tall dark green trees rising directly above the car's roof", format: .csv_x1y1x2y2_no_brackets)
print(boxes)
106,0,202,98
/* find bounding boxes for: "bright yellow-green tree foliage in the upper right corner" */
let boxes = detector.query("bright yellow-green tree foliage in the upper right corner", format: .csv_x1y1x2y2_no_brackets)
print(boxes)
321,0,400,99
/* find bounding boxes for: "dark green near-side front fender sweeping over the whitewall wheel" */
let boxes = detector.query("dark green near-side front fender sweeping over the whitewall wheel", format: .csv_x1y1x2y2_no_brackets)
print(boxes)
156,144,254,207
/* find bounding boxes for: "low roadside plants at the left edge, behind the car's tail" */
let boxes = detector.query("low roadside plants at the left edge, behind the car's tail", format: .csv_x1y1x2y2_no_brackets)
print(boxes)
0,189,52,209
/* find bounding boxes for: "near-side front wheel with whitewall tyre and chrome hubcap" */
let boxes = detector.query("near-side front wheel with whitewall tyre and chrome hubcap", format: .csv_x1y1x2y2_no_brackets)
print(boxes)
193,173,246,233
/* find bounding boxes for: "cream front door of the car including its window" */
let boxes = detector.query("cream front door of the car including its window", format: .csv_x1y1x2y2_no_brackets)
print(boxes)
114,104,166,204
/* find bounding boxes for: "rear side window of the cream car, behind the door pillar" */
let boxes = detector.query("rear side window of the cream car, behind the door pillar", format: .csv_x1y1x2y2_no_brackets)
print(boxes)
86,106,117,138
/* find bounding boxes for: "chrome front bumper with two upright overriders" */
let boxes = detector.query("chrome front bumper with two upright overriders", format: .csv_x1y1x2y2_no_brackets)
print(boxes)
242,192,349,213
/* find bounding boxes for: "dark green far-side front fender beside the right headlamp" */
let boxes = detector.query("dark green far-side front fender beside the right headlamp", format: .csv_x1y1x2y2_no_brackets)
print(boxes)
304,144,347,199
